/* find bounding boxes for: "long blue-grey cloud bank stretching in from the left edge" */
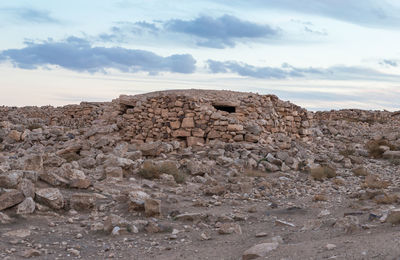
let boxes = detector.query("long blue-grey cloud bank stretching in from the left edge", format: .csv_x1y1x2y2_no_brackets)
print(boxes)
0,37,196,74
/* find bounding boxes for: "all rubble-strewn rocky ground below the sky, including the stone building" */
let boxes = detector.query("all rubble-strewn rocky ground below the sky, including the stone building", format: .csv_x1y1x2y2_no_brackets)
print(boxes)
0,90,400,260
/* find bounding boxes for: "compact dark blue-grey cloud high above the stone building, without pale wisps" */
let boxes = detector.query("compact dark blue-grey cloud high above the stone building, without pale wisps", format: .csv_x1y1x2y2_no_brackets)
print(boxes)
164,15,278,48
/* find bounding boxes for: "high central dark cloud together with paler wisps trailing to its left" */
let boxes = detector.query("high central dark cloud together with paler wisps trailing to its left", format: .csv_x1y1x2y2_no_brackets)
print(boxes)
97,15,279,49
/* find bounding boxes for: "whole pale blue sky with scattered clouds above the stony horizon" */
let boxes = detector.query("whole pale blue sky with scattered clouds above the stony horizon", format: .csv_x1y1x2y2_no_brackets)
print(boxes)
0,0,400,111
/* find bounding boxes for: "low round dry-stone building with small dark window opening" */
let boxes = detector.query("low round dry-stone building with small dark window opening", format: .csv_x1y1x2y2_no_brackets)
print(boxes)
113,90,313,146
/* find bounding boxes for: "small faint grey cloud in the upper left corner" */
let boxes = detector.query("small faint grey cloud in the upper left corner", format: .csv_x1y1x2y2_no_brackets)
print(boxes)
0,7,60,23
